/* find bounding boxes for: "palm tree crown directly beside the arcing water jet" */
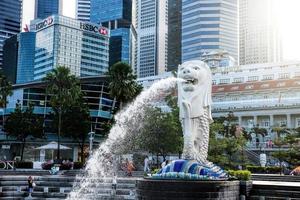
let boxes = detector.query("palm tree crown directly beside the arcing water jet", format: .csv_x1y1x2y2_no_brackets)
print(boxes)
108,62,142,109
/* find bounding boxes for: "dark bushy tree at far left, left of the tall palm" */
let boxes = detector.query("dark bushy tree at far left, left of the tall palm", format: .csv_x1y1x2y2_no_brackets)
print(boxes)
5,102,44,160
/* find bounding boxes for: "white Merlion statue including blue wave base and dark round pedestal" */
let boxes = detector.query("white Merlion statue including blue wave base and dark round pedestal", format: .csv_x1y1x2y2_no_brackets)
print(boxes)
137,60,239,200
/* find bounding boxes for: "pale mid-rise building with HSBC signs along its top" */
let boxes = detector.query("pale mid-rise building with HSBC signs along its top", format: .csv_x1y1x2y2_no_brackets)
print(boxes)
17,15,109,82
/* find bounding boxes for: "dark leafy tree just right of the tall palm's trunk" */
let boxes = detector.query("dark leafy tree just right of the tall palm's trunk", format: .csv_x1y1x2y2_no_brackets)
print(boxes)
62,97,91,162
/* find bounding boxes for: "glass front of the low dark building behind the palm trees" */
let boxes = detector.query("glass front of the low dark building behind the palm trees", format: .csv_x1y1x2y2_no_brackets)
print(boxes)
0,76,118,161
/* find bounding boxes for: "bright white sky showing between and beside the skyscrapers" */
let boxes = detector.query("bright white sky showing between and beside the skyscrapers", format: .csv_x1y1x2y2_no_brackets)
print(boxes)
22,0,300,60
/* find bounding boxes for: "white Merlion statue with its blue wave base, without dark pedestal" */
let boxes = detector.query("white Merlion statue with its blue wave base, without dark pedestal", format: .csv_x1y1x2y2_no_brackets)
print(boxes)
152,60,228,180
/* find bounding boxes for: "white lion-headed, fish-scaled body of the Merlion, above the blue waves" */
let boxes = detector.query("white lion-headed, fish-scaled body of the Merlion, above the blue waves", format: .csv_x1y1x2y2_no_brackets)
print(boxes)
178,60,212,164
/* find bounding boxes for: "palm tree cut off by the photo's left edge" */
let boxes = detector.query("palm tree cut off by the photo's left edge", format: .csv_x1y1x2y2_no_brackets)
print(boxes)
0,74,12,127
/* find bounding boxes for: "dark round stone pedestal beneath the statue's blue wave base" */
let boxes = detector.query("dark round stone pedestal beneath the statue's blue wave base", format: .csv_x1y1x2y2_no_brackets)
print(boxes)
136,179,240,200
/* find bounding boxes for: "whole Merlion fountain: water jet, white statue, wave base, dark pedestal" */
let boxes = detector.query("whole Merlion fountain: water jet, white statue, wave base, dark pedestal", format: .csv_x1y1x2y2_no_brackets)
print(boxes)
68,61,239,200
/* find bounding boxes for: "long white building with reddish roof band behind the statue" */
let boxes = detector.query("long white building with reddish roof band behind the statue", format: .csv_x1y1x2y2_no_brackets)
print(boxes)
139,62,300,129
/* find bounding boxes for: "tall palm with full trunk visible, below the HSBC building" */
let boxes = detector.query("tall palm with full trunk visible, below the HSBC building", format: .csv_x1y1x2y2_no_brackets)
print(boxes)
44,66,81,159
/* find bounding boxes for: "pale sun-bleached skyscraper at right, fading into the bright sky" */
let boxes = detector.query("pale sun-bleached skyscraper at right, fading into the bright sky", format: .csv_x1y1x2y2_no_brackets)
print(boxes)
239,0,282,65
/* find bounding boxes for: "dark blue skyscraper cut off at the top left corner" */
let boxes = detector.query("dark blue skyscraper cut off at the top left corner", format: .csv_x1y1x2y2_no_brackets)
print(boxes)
0,0,22,68
